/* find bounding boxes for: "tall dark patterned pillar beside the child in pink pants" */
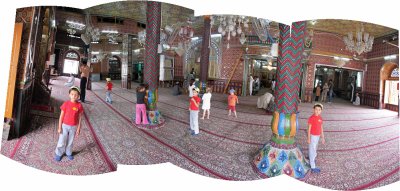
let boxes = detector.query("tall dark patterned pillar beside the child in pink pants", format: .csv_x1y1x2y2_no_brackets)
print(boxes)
143,1,165,128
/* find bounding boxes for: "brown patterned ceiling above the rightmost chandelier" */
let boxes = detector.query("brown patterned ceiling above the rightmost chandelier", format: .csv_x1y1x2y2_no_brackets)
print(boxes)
307,19,397,38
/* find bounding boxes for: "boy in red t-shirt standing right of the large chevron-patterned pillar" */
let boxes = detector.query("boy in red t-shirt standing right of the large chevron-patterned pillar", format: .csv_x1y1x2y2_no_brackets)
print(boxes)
307,103,325,173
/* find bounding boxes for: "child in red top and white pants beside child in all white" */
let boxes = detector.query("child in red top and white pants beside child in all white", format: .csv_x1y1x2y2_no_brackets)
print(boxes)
189,87,201,136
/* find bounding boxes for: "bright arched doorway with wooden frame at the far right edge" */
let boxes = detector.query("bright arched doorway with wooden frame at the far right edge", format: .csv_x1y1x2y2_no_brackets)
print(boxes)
379,62,399,111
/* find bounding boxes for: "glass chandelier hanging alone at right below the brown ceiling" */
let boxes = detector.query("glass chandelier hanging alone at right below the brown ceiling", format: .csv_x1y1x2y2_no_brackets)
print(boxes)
343,24,374,55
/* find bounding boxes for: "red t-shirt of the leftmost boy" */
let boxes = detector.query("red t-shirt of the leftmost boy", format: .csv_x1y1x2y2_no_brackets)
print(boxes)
60,101,83,126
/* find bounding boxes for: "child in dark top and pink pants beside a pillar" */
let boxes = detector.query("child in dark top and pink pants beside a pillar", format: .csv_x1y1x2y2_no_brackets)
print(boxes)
135,84,149,125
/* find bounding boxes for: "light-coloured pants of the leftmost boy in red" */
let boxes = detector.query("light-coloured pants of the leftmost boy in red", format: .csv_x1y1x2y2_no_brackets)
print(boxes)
56,124,76,156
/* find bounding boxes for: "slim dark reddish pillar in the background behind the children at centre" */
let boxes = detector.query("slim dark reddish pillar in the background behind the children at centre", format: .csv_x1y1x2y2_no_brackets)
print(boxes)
200,15,211,92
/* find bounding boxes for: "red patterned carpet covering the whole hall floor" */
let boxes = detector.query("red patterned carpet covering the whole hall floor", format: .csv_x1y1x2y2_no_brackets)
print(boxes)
1,77,400,190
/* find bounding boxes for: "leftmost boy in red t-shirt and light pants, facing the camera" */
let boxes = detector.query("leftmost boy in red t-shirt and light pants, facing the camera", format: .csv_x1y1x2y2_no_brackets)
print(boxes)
54,86,83,161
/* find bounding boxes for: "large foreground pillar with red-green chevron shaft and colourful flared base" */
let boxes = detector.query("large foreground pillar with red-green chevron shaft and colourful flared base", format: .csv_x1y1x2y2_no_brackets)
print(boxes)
253,21,310,179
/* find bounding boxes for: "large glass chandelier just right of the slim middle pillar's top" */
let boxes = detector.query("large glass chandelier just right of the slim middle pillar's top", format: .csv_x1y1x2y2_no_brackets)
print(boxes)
211,15,249,48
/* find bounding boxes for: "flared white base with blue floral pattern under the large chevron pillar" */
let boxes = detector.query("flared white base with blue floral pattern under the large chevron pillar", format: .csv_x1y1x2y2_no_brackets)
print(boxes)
252,141,310,179
